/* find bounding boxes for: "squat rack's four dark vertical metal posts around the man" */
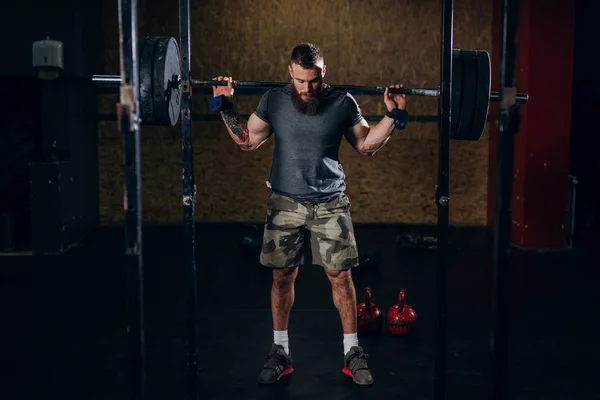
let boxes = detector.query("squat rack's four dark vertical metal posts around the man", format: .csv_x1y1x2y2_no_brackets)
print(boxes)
117,0,519,400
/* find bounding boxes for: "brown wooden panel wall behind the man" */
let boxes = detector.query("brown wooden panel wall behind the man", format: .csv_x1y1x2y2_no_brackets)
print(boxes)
99,0,493,225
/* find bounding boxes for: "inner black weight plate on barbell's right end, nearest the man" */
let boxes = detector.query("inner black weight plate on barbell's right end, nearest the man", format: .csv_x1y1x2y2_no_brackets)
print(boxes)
454,50,477,140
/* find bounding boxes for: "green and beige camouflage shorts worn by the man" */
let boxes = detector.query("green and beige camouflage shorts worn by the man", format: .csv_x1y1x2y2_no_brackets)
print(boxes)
260,191,358,270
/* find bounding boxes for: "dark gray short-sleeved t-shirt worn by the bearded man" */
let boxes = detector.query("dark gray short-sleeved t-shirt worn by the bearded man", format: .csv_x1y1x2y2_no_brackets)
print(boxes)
255,84,363,202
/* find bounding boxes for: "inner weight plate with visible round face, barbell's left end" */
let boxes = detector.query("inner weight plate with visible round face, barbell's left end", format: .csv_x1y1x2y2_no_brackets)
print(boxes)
152,37,181,126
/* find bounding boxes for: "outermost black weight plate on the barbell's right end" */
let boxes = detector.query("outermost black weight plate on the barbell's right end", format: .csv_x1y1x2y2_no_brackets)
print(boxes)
464,50,491,141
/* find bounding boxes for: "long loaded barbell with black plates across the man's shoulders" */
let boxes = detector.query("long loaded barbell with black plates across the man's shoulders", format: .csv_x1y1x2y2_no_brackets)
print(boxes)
92,37,529,141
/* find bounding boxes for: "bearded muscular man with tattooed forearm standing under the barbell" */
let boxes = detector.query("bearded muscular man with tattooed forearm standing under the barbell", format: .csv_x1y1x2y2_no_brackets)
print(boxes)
213,43,406,385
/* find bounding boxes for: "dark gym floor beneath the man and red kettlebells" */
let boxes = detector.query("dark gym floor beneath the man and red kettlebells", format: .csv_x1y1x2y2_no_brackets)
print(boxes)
0,225,600,400
